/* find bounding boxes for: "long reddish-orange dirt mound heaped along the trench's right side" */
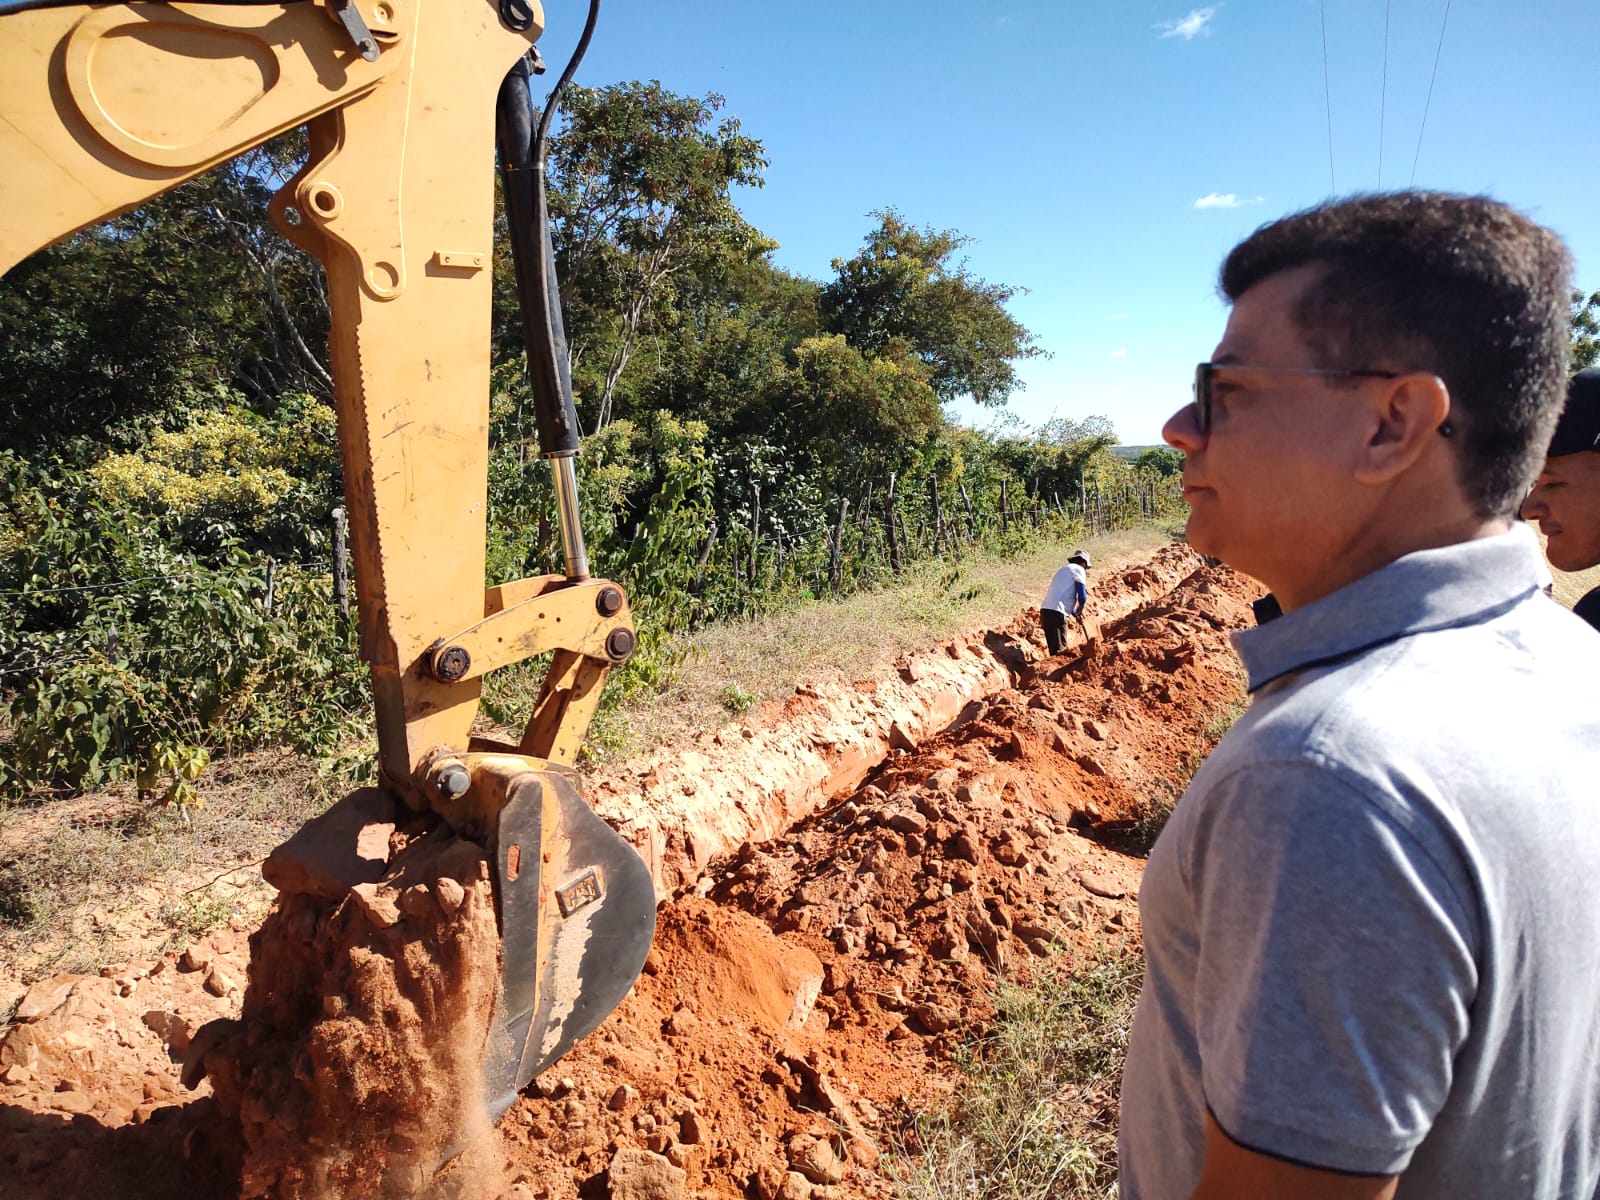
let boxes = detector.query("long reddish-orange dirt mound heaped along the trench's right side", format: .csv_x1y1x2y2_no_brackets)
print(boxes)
501,570,1256,1200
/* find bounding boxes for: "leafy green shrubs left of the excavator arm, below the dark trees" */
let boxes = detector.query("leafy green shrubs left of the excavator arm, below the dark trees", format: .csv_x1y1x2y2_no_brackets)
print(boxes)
0,461,366,805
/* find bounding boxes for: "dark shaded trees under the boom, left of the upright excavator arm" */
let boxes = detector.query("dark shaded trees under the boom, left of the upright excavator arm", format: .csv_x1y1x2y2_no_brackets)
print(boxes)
0,134,331,448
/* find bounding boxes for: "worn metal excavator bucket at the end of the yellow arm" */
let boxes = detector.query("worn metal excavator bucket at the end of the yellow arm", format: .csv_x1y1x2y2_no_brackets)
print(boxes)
483,770,656,1120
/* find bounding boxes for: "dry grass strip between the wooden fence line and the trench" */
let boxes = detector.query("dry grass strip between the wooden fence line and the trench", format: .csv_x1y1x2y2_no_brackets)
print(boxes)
588,526,1171,771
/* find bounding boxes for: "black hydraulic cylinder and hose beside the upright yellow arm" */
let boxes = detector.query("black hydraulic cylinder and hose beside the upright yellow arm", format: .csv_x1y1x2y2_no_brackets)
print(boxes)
494,0,600,458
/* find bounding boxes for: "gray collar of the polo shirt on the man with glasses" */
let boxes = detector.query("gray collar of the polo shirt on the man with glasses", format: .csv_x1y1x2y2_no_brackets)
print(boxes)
1232,523,1549,691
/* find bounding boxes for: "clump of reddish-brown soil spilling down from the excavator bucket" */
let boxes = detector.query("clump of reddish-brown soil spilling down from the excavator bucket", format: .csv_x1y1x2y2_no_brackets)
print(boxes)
199,812,504,1200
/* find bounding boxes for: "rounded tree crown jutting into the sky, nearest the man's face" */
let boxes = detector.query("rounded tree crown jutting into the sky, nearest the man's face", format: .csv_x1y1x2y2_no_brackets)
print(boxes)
821,208,1043,405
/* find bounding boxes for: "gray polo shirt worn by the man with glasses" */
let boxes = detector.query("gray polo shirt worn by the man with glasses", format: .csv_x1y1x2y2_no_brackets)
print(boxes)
1120,530,1600,1200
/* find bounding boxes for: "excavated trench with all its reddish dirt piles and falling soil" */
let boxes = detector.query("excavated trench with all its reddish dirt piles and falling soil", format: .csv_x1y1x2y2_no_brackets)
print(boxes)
0,547,1254,1200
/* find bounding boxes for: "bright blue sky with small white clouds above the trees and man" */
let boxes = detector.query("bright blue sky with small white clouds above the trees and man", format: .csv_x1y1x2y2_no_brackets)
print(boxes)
541,0,1600,443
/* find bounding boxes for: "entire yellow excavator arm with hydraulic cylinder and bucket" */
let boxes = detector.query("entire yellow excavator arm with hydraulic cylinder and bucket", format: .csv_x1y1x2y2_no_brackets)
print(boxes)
0,0,654,1117
